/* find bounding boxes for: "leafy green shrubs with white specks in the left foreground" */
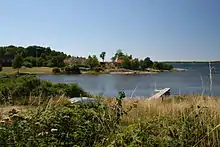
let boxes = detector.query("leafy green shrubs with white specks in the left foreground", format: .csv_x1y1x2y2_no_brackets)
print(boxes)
0,103,116,146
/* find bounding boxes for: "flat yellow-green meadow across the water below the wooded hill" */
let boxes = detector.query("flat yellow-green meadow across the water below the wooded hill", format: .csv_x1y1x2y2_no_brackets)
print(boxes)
0,67,53,75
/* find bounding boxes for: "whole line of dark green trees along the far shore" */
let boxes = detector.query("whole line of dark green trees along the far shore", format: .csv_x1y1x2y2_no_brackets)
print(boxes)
0,45,173,73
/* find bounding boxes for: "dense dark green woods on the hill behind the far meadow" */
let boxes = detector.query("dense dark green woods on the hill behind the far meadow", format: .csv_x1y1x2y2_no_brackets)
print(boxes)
0,45,68,67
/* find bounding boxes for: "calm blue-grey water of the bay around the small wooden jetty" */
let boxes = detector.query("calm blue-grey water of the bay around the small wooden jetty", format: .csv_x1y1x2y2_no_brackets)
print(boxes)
39,63,220,96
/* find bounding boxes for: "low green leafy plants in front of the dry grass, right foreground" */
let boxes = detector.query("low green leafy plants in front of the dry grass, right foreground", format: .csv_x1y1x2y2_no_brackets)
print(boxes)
102,104,220,147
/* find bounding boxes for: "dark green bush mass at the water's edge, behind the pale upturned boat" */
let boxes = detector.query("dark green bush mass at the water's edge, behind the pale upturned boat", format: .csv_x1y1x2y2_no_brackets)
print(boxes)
0,76,87,104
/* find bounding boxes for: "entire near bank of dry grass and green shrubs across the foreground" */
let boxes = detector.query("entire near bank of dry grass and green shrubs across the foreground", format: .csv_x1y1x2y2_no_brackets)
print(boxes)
0,96,220,147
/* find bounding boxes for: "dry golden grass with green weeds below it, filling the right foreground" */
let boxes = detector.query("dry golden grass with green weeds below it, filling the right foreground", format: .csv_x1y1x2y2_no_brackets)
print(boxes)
105,96,220,146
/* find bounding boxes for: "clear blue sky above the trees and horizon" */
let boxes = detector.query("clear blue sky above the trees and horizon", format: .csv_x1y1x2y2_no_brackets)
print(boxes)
0,0,220,61
